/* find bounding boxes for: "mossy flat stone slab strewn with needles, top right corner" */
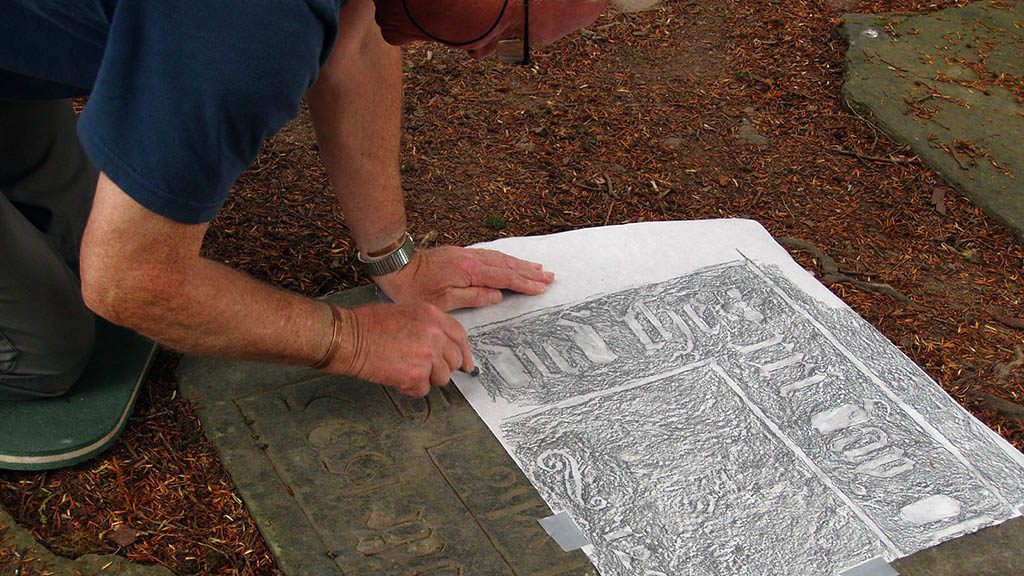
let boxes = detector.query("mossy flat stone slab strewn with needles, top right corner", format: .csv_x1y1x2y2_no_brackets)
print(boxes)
840,0,1024,240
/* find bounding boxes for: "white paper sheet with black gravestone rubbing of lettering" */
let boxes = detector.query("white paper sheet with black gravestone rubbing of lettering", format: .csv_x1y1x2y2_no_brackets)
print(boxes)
455,220,1024,576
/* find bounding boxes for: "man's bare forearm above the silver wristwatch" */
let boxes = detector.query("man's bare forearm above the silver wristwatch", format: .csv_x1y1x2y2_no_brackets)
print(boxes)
307,0,406,252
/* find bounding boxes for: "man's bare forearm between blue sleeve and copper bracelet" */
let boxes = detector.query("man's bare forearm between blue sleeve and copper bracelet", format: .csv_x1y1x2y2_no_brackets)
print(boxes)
81,173,333,364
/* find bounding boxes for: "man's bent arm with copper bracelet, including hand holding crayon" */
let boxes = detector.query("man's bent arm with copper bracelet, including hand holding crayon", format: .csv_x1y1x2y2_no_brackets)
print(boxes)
81,173,472,396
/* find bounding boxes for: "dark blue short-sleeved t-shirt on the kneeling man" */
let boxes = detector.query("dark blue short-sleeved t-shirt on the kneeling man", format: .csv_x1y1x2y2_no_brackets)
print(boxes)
0,0,344,223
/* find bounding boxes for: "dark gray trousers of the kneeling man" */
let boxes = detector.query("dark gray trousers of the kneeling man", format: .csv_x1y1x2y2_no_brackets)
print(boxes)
0,99,98,401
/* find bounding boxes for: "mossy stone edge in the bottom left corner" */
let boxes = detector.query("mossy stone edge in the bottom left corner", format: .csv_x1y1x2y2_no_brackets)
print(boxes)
0,508,174,576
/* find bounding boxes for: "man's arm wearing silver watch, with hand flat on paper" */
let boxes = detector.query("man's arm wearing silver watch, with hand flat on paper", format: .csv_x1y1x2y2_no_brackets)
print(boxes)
306,0,554,310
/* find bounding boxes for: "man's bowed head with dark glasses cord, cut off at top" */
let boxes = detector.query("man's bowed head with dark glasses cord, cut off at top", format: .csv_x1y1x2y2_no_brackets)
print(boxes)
374,0,609,58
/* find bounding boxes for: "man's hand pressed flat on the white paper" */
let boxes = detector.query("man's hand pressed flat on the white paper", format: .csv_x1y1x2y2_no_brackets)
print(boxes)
374,246,555,311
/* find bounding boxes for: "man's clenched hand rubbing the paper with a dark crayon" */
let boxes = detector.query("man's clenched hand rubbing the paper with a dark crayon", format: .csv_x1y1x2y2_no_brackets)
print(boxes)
327,302,473,397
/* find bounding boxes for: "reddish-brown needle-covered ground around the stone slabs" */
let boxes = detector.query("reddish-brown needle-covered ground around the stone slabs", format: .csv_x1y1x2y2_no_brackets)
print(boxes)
0,0,1024,574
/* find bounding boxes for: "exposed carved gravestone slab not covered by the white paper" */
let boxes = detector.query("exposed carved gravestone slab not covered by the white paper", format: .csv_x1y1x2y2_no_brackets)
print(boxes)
178,288,1024,576
